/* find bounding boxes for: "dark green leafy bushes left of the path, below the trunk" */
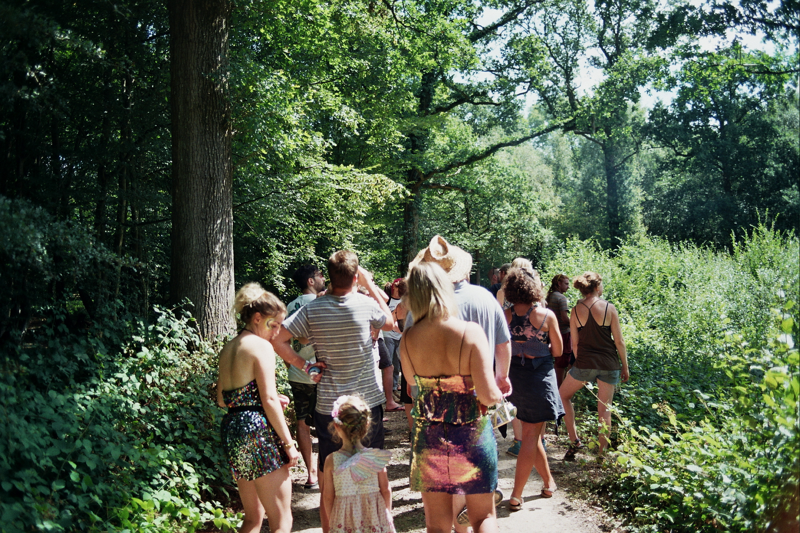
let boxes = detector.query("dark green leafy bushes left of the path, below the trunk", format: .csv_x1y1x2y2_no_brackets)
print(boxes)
0,309,239,532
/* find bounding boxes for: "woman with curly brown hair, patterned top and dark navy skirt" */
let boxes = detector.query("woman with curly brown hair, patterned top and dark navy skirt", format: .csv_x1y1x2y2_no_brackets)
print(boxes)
505,268,564,511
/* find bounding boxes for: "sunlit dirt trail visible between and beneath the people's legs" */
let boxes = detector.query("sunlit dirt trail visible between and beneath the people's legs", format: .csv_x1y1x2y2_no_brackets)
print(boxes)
284,413,622,533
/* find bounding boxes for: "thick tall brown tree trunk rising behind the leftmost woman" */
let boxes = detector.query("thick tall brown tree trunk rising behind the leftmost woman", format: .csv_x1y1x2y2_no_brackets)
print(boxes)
168,0,234,337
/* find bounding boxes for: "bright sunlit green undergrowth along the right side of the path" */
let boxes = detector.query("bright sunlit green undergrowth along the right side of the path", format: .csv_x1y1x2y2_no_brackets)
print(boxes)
545,225,800,531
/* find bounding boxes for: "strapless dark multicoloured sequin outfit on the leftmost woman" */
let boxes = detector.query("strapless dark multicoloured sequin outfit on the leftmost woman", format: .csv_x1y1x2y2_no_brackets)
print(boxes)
222,380,289,481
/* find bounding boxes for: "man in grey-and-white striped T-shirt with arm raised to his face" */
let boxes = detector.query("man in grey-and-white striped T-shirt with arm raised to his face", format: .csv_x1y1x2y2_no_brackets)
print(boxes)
272,250,394,524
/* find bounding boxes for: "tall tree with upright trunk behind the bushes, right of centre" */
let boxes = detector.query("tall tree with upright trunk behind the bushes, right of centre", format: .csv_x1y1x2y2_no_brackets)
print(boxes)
533,0,663,246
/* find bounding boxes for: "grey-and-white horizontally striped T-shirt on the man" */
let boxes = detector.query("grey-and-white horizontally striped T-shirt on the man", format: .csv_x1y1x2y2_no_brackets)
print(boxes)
283,292,386,415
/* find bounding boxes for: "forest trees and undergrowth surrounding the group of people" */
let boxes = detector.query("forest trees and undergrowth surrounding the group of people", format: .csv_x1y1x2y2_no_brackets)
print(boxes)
0,0,800,531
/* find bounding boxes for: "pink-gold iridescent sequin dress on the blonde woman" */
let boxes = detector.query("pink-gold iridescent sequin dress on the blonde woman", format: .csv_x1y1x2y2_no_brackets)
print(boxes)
410,375,497,494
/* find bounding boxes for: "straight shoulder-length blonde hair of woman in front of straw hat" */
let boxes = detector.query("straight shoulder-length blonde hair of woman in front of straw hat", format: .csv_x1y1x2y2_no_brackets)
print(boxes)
403,262,458,323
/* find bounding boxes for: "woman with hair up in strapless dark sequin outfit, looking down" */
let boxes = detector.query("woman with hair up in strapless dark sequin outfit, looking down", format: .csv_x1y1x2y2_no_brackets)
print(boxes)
217,283,300,533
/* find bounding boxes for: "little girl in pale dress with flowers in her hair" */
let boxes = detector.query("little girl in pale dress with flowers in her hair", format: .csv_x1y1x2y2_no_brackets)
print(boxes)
322,396,395,533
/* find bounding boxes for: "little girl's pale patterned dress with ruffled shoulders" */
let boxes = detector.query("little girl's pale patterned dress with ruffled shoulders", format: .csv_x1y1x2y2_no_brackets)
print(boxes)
330,448,395,533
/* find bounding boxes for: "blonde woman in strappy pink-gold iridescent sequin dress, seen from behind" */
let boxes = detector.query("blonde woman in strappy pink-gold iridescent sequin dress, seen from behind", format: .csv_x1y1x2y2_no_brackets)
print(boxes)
400,262,503,533
